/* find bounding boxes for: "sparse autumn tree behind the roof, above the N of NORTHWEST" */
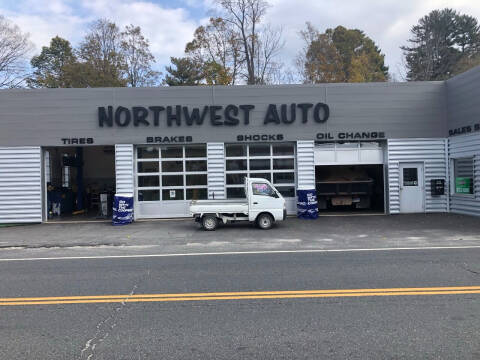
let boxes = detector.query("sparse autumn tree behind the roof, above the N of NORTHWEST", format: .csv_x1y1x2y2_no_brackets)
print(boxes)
78,19,127,87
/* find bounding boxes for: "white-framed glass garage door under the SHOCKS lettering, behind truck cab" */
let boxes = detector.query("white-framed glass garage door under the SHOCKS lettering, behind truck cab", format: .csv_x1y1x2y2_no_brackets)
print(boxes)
225,143,295,199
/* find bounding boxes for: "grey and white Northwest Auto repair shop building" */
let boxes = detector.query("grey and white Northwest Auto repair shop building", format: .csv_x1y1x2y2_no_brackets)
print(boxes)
0,67,480,223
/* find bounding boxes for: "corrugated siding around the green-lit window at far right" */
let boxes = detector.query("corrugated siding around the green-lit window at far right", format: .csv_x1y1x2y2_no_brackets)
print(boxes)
448,134,480,216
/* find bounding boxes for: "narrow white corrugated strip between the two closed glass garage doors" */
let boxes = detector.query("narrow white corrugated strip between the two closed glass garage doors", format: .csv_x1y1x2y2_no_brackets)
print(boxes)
207,143,225,199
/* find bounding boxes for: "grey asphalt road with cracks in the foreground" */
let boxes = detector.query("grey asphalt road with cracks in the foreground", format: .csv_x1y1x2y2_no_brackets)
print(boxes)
0,248,480,359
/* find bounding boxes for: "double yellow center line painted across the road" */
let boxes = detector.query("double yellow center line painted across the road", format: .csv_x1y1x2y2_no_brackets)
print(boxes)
0,286,480,306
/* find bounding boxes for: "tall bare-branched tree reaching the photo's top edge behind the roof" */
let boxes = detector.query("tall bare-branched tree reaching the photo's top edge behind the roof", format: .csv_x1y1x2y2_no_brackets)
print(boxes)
217,0,284,85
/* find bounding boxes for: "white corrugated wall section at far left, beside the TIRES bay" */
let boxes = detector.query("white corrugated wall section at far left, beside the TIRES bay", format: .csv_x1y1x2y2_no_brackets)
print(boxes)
0,147,42,224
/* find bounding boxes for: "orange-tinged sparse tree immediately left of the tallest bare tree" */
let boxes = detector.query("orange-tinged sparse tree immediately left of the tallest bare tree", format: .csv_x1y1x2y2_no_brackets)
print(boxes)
185,17,243,85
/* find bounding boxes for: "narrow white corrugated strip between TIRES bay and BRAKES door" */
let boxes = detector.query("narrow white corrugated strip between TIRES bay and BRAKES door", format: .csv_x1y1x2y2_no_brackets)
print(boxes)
115,144,135,194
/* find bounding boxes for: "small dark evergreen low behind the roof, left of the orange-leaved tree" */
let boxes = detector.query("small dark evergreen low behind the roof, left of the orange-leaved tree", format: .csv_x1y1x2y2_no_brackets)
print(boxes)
163,57,204,86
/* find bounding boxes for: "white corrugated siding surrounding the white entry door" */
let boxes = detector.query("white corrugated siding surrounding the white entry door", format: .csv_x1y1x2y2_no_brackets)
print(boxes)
387,139,448,214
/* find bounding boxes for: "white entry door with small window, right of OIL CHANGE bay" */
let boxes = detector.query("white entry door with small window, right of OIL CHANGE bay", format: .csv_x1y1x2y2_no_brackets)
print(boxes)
400,163,425,213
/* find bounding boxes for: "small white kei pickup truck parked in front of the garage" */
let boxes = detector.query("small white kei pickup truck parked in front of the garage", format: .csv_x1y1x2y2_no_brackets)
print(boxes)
190,177,287,231
